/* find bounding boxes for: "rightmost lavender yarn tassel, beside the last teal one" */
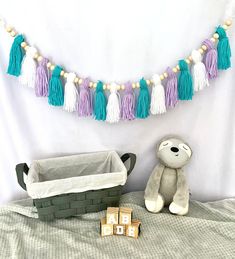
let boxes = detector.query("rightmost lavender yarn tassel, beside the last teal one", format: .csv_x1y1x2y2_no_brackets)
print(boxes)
203,39,218,79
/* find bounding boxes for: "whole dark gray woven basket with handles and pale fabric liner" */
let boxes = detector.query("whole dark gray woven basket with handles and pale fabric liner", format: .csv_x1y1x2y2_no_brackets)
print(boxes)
16,151,136,221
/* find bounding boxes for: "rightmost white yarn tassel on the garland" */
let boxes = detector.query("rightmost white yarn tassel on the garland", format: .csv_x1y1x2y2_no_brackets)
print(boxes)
192,50,209,92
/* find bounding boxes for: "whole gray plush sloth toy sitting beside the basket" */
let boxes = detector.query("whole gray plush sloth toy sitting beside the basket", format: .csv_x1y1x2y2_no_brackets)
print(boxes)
144,136,192,215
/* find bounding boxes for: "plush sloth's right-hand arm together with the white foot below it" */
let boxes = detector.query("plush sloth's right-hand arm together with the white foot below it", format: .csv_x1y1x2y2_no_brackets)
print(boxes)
170,169,189,215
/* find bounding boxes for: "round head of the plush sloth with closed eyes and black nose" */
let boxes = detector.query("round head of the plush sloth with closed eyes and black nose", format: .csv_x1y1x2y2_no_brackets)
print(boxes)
157,137,192,168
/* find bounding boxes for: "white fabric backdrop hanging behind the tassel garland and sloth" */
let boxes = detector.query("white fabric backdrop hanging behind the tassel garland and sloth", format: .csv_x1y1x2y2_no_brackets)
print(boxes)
0,0,235,203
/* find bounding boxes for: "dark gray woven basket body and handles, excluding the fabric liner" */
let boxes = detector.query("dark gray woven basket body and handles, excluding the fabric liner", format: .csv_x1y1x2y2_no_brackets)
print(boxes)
16,153,136,221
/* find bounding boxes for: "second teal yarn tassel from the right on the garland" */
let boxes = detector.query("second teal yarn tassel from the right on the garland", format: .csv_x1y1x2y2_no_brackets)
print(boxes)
178,60,193,100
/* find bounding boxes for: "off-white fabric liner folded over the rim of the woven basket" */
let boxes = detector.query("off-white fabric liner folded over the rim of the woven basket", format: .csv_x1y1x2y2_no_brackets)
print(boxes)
25,151,127,199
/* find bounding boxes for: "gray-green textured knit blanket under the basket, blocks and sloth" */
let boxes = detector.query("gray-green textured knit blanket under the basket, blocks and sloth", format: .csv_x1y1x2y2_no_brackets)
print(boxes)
0,192,235,259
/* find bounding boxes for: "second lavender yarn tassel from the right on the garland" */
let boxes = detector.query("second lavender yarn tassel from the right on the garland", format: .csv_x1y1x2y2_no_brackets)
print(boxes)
165,67,178,109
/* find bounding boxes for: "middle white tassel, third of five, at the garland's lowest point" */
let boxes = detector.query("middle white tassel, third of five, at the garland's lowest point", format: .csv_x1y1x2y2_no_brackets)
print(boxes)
106,83,120,123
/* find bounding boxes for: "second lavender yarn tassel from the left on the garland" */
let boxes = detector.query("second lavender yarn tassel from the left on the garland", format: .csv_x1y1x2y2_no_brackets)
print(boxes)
78,78,92,117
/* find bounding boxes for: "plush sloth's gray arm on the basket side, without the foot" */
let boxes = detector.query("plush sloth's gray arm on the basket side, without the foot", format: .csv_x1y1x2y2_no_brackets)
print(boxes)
144,164,165,201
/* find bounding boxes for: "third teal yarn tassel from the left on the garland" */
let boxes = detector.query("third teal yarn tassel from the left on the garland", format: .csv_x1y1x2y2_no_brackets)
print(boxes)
94,81,107,121
